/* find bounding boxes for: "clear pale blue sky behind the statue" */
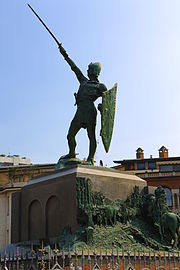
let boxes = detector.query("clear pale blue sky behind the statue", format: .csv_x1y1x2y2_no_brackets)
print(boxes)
0,0,180,166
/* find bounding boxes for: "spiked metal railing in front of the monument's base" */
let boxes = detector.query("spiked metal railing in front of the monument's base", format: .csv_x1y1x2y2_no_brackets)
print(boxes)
0,245,180,270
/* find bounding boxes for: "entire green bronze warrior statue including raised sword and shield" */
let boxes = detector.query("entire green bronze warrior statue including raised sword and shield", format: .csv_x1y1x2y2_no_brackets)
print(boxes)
28,4,117,168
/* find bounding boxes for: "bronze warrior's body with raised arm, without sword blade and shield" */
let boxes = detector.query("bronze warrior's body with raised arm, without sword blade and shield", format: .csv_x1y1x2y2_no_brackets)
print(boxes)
59,46,107,165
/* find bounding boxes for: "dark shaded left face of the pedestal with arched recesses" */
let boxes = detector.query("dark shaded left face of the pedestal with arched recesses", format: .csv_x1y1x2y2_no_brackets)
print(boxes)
12,174,78,242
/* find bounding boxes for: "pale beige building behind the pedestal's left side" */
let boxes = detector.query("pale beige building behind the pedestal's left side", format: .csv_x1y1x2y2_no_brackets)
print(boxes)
0,156,56,248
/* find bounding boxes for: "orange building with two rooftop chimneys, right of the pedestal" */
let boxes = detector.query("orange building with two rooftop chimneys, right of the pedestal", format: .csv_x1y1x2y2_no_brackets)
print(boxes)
114,146,180,214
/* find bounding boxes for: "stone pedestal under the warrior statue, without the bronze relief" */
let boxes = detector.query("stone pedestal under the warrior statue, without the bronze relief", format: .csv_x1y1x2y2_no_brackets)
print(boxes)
11,165,146,243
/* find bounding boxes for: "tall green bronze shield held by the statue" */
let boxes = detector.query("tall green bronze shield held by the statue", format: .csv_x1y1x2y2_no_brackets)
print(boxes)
100,83,117,153
